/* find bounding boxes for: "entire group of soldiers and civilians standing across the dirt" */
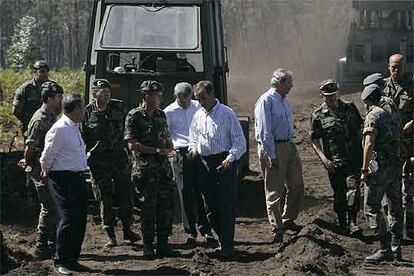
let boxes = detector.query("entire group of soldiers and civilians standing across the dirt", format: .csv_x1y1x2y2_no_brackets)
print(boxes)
13,51,413,275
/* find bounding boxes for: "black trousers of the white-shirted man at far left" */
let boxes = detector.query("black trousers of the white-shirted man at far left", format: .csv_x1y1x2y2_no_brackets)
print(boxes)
49,171,88,265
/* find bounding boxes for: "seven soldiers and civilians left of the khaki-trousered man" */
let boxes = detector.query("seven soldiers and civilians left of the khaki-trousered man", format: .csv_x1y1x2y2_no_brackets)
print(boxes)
13,61,246,275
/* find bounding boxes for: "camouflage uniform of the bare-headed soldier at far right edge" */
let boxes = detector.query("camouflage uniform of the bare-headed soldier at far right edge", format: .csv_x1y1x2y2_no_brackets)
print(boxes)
383,75,414,189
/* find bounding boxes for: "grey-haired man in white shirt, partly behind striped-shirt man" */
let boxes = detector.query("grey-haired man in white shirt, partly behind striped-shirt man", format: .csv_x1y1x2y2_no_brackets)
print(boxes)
164,82,216,247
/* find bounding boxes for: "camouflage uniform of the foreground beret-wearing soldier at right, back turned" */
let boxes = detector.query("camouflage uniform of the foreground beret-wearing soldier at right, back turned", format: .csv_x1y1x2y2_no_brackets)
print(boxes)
363,106,403,246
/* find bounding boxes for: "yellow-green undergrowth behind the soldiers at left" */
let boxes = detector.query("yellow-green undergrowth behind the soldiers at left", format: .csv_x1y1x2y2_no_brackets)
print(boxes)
0,68,85,151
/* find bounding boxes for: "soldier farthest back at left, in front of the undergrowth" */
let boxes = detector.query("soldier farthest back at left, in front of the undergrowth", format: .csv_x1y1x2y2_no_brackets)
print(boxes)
12,60,49,205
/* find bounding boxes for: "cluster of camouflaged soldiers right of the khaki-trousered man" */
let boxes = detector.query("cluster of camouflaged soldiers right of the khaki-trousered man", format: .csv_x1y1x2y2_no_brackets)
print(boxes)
310,54,414,262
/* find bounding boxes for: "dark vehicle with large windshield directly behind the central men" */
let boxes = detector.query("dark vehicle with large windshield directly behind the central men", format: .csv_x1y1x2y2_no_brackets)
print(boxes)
85,0,248,170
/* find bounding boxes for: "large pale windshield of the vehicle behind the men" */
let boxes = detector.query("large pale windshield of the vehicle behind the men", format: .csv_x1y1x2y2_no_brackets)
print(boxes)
100,5,201,51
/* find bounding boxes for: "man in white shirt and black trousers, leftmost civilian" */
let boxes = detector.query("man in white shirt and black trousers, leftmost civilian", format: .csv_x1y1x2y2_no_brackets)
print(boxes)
40,95,88,275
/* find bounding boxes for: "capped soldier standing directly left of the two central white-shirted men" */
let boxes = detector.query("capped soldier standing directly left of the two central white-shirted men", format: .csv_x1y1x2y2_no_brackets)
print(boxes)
124,81,176,259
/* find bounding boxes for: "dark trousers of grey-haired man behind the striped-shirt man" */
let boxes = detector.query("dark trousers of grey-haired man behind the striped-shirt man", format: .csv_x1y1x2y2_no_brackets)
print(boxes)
172,148,211,237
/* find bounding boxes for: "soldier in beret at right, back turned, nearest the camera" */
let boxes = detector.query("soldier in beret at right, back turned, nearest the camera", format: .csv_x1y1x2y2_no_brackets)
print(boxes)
361,84,403,263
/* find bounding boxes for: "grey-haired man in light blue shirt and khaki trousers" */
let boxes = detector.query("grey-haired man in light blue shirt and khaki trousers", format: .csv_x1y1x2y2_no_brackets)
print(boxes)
254,68,304,242
